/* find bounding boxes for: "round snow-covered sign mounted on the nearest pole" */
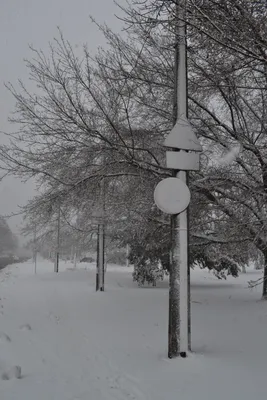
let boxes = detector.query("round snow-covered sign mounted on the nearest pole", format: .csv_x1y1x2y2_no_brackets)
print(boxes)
154,178,191,214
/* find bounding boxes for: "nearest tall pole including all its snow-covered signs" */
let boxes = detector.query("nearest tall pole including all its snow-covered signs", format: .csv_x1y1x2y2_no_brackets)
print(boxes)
154,1,202,358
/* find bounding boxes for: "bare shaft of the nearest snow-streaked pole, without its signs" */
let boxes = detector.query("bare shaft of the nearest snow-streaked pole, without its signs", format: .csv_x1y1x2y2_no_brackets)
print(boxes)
168,0,190,358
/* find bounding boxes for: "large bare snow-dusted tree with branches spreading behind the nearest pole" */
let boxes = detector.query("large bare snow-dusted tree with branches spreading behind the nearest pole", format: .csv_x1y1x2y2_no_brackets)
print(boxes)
0,0,267,297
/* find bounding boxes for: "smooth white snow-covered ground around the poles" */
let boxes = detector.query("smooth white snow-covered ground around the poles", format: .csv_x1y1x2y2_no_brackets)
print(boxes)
0,261,267,400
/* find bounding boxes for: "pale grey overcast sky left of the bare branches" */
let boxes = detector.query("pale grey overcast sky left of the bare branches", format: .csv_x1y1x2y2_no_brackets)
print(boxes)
0,0,125,241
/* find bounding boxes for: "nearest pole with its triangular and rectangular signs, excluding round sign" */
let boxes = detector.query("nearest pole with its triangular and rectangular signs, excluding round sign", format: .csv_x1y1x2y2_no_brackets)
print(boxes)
168,0,202,358
